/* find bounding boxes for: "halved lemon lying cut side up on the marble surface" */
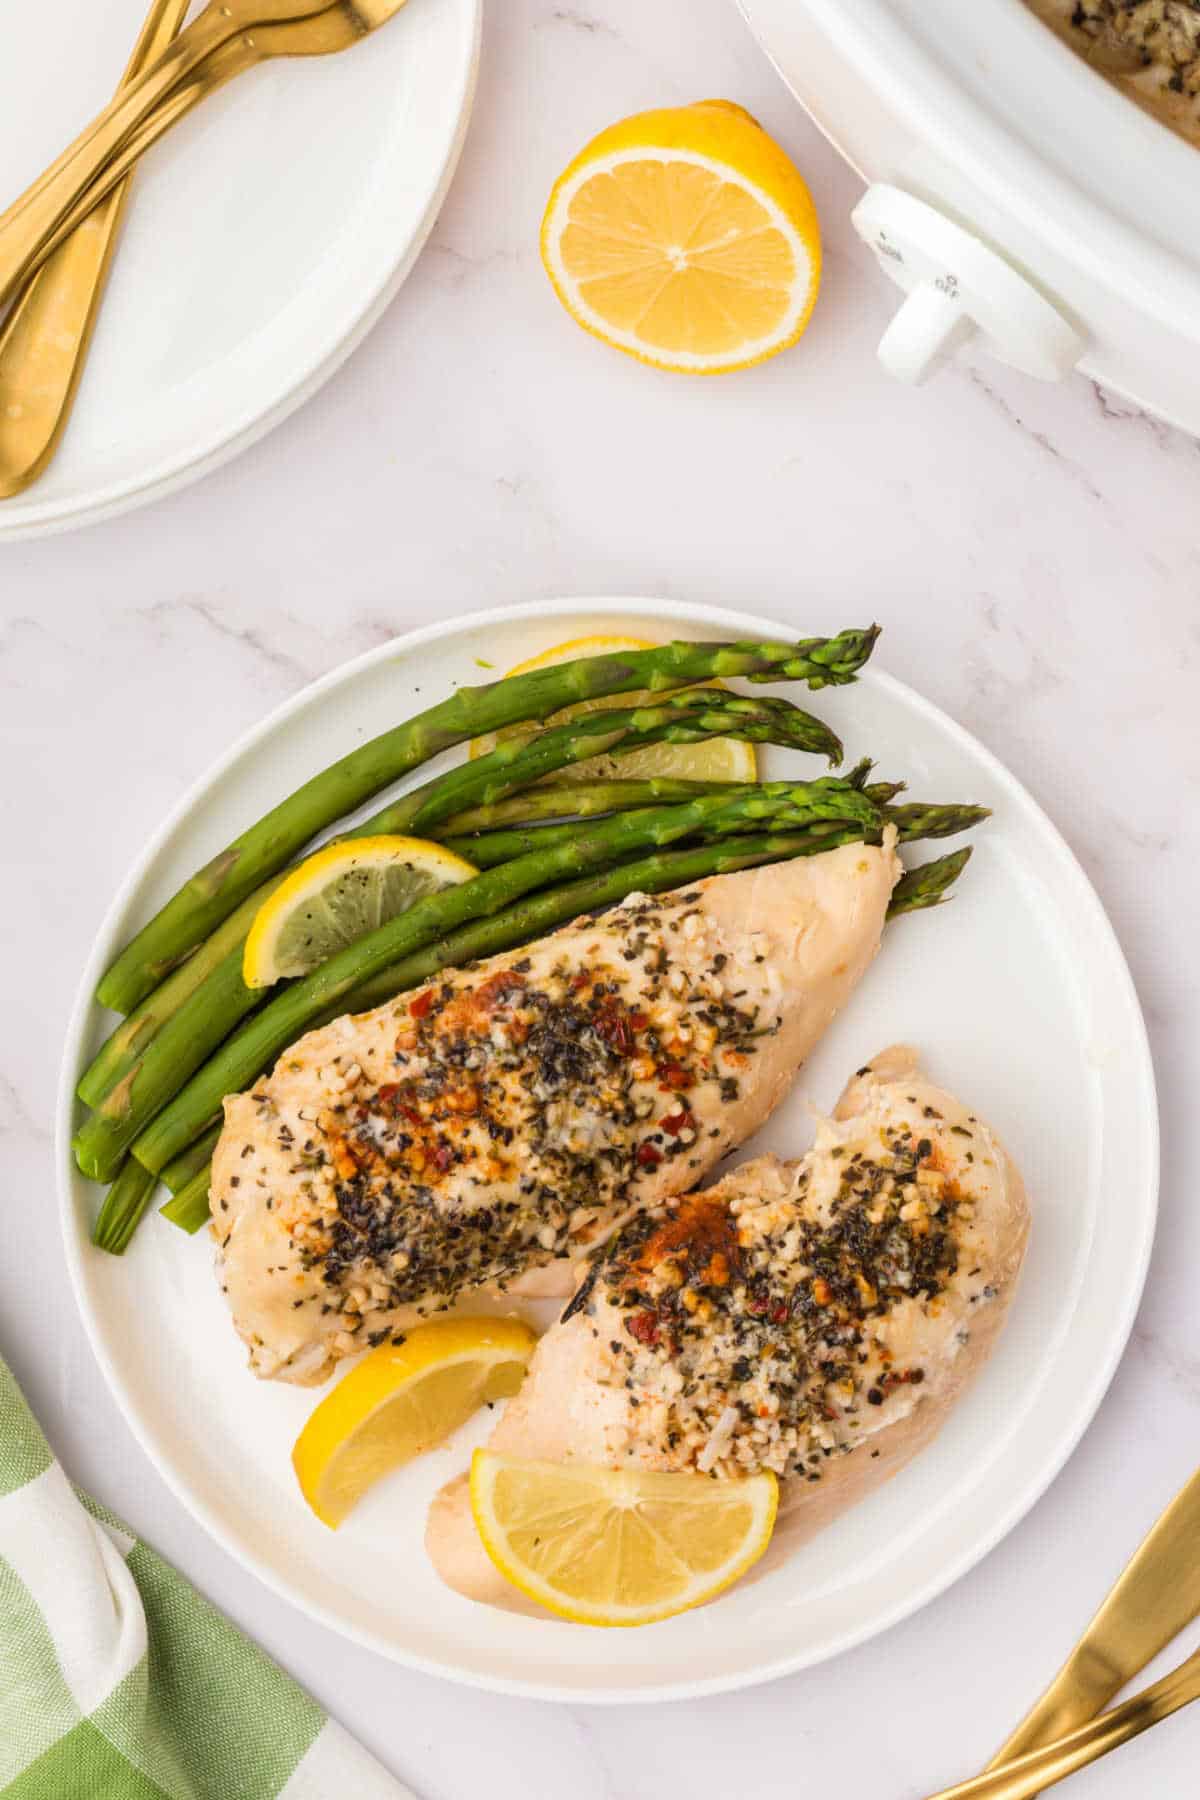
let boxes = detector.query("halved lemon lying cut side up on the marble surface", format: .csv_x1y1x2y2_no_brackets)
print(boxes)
542,101,820,374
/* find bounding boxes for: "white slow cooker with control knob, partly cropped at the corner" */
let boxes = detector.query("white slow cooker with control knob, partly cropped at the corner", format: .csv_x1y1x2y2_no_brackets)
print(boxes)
739,0,1200,434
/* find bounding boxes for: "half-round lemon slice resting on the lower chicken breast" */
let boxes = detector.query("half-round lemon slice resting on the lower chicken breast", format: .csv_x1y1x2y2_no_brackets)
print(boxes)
471,1451,779,1625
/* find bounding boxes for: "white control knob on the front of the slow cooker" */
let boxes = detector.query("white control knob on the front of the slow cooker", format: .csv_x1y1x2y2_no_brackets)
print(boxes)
851,182,1085,382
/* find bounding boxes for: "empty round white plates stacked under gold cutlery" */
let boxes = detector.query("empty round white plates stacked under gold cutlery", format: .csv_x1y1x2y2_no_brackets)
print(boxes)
0,0,482,538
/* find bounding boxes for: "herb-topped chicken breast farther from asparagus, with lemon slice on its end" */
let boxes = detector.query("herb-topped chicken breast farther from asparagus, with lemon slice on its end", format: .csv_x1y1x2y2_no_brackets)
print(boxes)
426,1048,1029,1618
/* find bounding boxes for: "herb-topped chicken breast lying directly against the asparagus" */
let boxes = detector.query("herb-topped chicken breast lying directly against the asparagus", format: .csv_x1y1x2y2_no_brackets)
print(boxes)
210,833,900,1382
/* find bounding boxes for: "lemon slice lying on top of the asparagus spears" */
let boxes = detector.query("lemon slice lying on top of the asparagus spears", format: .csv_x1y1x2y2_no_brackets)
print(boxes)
241,837,479,988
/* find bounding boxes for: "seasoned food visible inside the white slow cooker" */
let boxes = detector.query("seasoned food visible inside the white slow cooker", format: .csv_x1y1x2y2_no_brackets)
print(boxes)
1027,0,1200,142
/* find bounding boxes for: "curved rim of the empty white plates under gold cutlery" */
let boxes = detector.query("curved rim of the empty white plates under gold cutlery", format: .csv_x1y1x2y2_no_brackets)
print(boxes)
0,0,484,544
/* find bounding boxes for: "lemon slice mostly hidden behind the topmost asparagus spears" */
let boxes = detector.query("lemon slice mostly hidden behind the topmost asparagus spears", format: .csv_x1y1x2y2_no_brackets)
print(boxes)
471,635,757,785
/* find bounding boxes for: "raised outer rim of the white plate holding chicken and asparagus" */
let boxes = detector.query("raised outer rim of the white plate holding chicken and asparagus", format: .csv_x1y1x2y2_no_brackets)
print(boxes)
54,594,1160,1706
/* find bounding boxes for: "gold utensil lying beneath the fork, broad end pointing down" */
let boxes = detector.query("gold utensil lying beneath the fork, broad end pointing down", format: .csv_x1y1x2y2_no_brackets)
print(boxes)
0,0,189,499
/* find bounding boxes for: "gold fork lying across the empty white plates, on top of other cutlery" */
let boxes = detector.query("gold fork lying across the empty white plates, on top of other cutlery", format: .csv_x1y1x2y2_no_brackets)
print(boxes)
0,0,413,306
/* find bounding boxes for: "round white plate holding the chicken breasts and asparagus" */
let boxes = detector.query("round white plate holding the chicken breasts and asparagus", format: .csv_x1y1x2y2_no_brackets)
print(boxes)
58,599,1157,1701
